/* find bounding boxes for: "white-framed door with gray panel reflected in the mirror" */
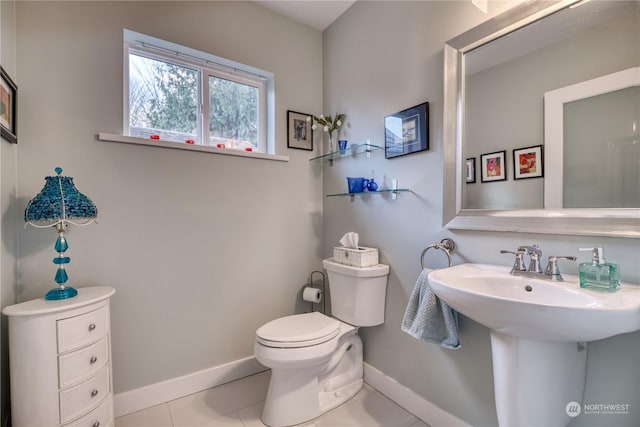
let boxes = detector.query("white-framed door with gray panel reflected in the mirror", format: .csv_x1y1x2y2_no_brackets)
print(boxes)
544,67,640,208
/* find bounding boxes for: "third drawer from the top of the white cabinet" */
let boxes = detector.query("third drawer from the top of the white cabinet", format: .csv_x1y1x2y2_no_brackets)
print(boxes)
60,366,110,424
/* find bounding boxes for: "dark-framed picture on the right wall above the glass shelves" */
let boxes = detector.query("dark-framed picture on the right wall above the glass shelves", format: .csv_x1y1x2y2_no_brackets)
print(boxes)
384,102,429,159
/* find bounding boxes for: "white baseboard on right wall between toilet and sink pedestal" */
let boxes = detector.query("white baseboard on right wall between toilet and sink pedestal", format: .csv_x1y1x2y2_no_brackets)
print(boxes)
364,363,472,427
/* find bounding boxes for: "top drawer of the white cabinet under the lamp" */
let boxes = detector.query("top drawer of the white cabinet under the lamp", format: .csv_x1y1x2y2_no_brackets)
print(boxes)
57,305,109,353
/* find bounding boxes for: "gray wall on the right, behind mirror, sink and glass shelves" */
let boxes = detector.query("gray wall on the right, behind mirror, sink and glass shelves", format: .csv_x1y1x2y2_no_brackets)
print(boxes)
323,1,640,426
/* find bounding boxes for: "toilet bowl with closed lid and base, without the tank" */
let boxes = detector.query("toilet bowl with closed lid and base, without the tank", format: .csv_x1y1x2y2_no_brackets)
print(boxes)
254,312,363,427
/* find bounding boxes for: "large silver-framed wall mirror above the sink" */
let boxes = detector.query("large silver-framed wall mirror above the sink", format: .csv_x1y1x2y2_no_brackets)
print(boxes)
443,0,640,238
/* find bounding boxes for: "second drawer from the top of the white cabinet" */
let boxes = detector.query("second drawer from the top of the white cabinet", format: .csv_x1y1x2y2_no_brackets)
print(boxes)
58,335,109,388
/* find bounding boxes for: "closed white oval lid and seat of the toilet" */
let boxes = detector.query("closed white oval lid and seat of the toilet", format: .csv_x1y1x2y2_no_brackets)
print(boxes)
256,312,340,347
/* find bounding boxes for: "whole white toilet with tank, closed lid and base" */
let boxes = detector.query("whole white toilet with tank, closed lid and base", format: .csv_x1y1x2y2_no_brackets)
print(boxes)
254,258,389,427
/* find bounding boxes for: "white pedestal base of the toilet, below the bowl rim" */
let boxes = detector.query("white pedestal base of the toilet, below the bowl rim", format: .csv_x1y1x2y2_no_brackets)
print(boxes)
261,330,364,427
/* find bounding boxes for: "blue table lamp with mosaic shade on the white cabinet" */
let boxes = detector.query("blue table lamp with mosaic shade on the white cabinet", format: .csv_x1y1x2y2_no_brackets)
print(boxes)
24,168,98,300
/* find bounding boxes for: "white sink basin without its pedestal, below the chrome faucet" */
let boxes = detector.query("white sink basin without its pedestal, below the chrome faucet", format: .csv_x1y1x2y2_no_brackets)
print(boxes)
429,264,640,342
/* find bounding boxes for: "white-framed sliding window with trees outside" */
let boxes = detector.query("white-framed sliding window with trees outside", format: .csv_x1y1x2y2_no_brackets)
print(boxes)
124,30,274,153
